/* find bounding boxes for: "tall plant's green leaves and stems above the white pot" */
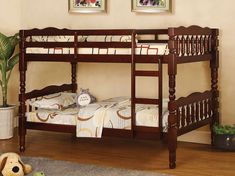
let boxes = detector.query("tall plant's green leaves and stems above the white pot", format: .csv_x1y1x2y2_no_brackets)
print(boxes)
0,32,19,107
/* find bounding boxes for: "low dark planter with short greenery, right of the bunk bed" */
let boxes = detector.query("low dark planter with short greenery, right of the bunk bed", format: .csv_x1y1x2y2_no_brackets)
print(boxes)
213,125,235,151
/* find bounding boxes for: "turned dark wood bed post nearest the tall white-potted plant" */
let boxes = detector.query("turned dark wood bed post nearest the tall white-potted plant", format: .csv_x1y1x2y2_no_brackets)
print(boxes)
19,30,27,152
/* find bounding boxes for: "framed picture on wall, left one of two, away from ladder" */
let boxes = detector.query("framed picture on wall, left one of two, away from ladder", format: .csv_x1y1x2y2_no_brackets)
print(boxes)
69,0,106,13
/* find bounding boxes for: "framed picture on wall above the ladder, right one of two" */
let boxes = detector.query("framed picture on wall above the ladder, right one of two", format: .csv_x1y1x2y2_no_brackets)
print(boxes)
132,0,171,13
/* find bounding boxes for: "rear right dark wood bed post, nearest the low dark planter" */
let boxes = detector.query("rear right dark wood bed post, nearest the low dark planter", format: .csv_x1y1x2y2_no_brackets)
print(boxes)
210,29,219,145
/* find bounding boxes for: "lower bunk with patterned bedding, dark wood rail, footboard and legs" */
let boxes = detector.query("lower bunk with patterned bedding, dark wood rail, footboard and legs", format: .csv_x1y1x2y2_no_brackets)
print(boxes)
19,88,218,168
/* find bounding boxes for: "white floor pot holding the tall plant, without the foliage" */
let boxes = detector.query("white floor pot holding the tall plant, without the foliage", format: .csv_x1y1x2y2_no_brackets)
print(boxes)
0,106,16,139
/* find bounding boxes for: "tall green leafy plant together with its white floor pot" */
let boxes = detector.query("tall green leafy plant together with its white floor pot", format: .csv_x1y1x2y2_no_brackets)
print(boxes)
0,32,19,139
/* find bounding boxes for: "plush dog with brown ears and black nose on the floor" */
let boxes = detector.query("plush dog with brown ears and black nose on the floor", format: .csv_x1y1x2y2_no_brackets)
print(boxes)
0,153,32,176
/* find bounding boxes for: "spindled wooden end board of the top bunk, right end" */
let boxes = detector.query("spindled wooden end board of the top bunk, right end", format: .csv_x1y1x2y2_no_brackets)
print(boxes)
168,26,218,64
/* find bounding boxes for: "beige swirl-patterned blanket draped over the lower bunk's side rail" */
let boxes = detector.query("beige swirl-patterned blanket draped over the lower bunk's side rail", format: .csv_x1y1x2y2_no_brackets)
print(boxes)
77,97,167,138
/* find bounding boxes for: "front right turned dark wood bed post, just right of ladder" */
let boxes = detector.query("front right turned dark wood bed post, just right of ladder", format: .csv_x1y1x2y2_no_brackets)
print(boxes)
168,28,177,169
